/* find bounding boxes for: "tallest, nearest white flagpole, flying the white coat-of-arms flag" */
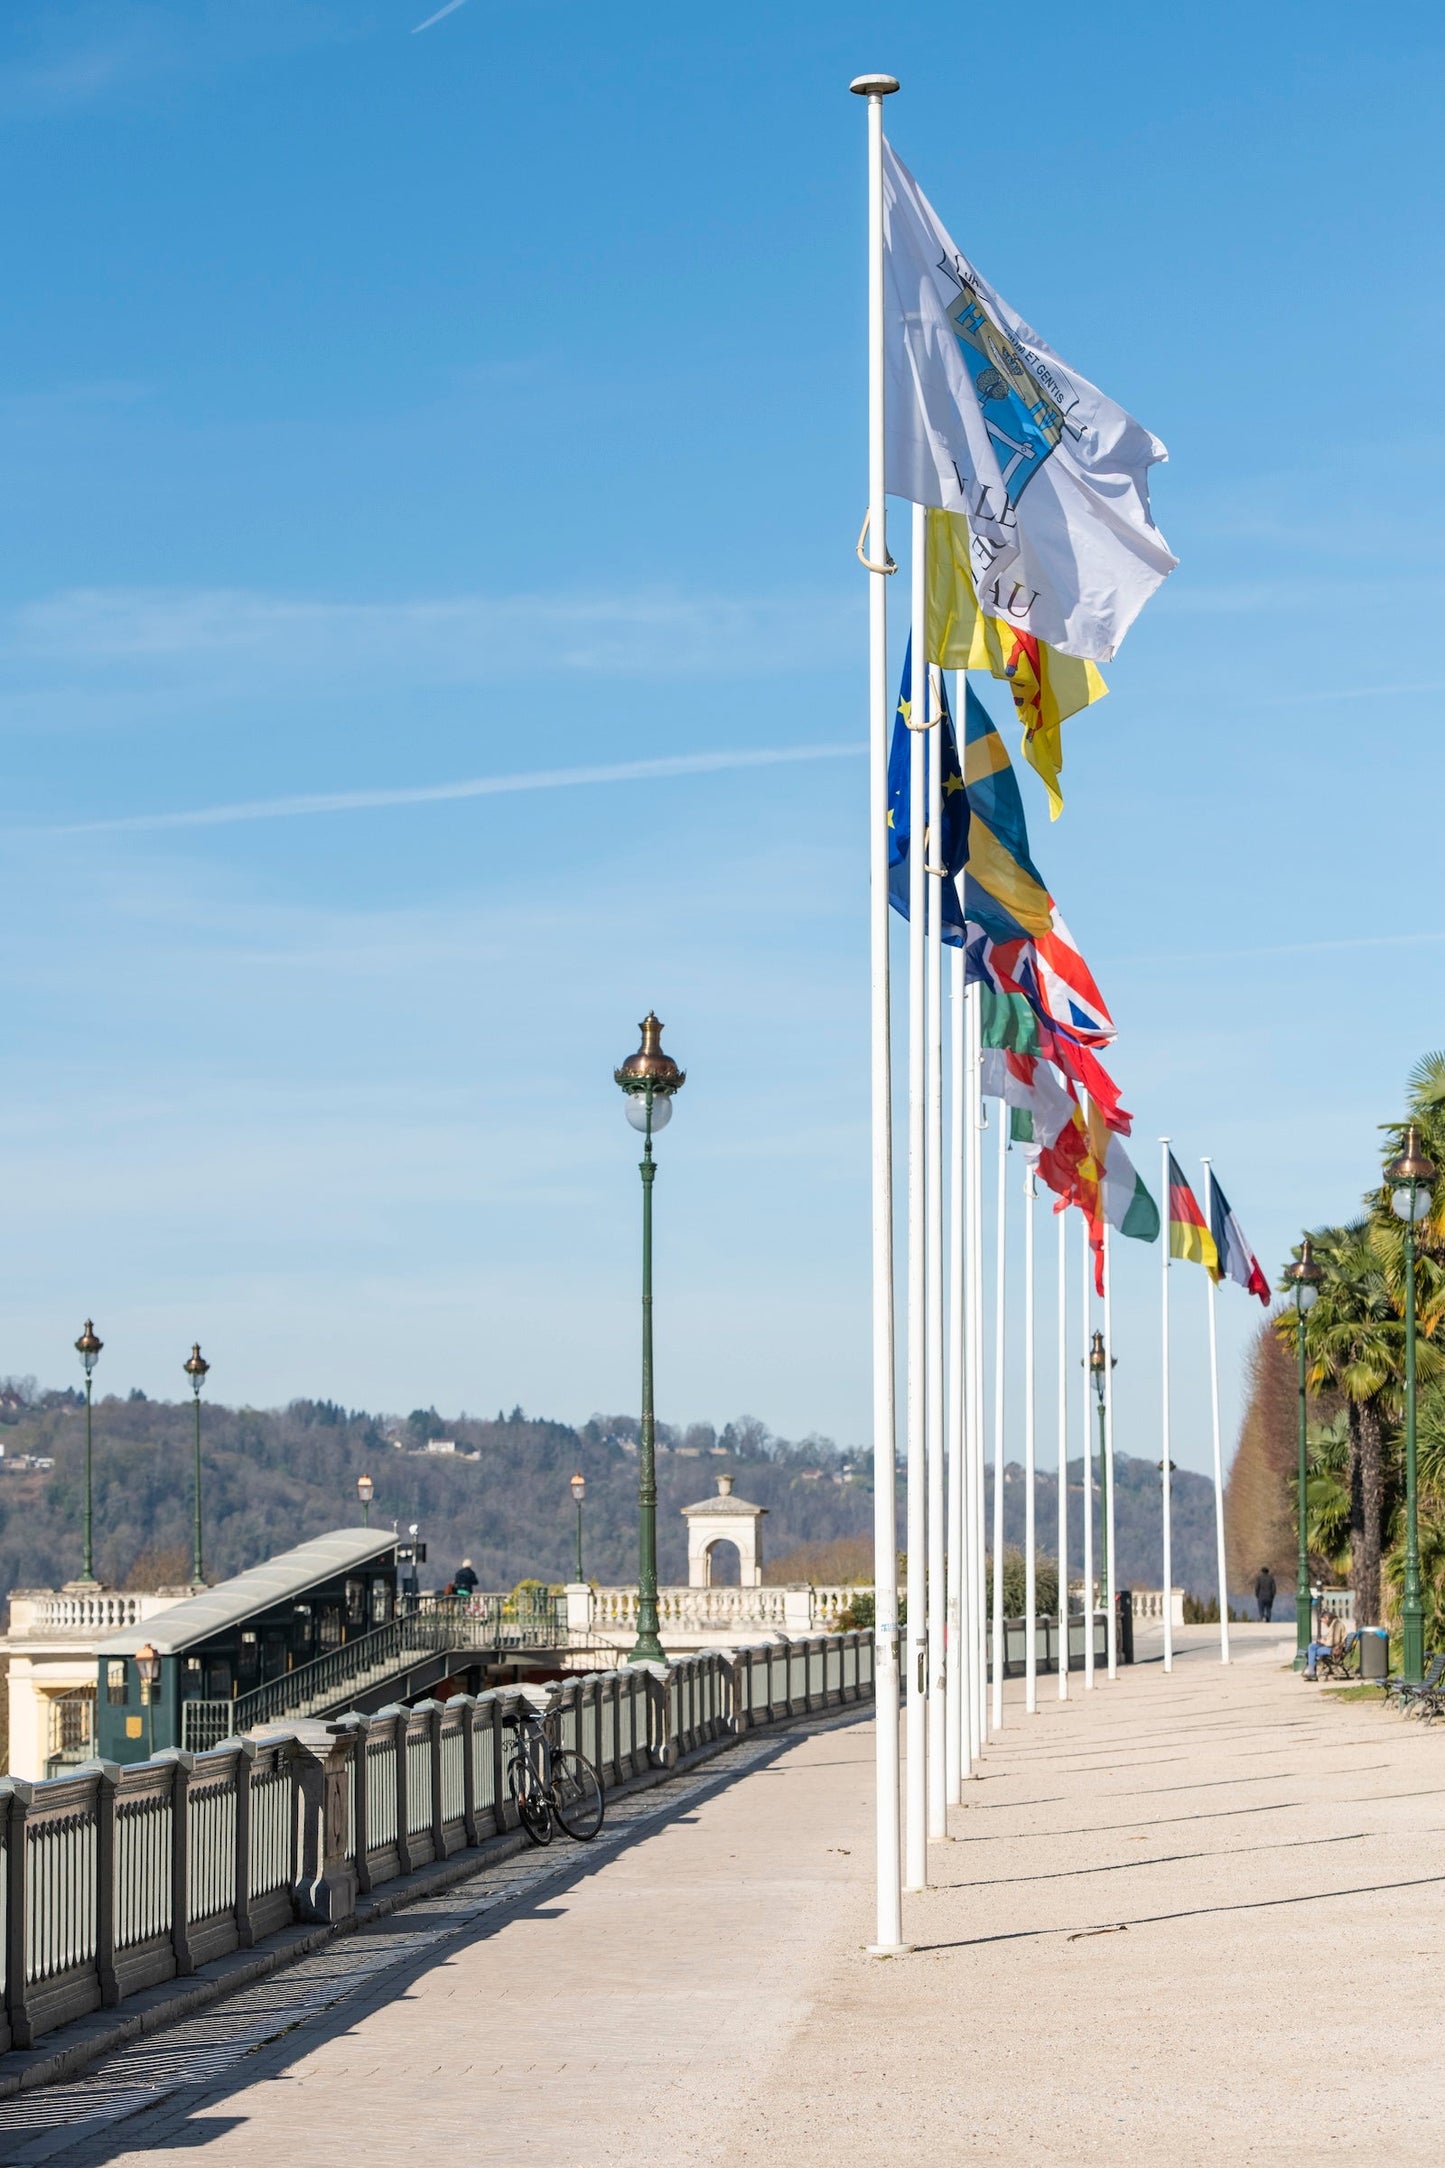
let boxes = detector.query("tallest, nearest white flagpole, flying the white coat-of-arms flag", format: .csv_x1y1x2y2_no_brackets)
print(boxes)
854,76,906,1958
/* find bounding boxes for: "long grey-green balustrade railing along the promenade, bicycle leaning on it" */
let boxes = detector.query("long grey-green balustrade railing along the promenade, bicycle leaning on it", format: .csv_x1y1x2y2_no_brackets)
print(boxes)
0,1633,873,2051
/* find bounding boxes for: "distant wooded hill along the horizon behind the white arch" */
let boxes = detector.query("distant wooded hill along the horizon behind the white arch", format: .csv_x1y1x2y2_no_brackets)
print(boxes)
0,1394,1215,1596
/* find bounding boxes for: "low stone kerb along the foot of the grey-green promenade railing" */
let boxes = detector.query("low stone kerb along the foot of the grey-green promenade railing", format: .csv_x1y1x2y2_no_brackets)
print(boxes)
0,1702,873,2101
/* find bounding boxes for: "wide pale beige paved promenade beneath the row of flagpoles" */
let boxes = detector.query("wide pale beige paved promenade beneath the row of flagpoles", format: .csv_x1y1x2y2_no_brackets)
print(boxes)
0,1628,1445,2168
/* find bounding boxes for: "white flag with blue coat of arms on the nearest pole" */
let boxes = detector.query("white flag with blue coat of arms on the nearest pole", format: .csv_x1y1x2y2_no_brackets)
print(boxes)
884,143,1179,661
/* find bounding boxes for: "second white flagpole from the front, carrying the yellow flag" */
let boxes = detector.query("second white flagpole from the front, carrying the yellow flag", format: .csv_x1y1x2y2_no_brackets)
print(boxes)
903,505,927,1890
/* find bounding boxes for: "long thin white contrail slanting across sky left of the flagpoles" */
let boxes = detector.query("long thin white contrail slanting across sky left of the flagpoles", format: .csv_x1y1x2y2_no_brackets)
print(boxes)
39,741,867,835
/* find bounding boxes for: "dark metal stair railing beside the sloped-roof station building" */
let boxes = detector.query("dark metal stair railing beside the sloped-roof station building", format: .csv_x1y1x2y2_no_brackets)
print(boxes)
180,1591,568,1754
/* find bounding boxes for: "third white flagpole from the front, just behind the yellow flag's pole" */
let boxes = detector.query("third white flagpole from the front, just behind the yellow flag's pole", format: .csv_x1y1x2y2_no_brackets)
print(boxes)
921,663,949,1843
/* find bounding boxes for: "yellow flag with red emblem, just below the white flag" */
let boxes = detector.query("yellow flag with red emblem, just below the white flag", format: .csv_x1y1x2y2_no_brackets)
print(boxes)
927,509,1109,820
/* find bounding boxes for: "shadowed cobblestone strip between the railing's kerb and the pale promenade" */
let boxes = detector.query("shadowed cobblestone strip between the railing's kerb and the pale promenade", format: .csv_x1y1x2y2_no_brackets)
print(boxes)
0,1708,871,2168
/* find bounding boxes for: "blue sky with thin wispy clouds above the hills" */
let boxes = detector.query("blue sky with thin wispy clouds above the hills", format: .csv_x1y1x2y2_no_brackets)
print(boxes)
0,0,1445,1491
